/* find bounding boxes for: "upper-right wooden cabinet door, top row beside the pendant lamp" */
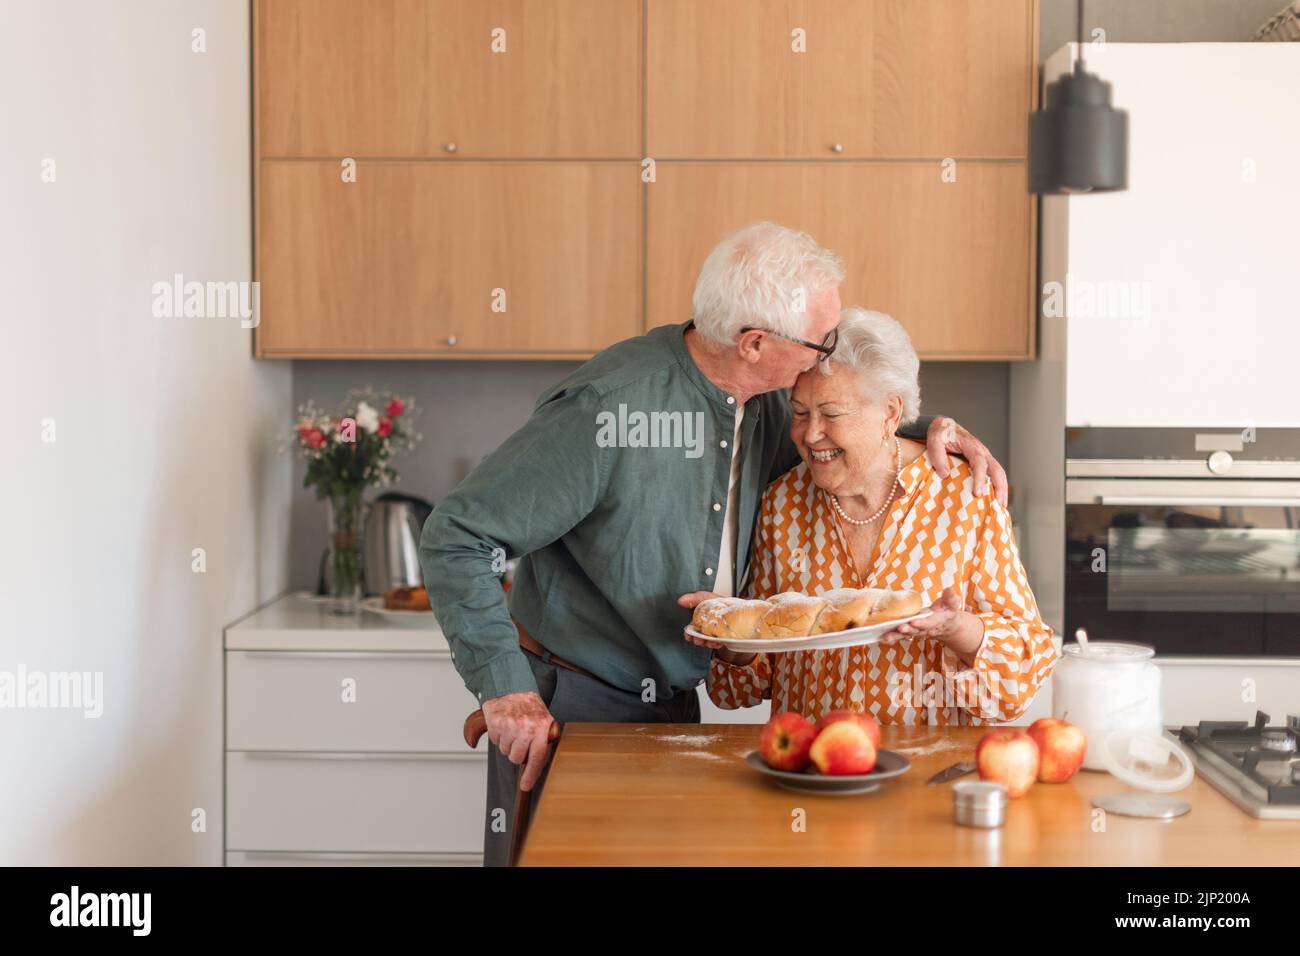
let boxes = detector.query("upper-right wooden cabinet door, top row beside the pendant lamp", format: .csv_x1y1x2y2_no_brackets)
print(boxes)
646,0,1037,159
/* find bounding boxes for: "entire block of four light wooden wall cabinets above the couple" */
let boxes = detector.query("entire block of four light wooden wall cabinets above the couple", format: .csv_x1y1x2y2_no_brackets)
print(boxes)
254,0,1037,359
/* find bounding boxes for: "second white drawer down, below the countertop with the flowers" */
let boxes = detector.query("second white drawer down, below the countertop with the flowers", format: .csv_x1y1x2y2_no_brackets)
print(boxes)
226,752,488,853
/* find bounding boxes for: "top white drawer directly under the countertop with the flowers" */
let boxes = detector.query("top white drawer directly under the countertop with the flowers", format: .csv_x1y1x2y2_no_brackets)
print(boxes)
226,650,488,753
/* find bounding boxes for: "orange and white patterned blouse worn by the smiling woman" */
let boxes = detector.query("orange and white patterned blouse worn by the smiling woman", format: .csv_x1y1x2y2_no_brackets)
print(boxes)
709,454,1057,724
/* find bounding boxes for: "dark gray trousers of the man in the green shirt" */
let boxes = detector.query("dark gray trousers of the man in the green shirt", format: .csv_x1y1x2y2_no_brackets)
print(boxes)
484,650,699,866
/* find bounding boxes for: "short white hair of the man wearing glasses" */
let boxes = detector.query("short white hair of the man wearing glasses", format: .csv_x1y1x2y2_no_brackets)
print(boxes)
692,222,844,345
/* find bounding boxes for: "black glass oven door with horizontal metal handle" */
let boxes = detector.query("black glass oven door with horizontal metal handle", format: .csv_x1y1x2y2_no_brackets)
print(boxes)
1065,479,1300,657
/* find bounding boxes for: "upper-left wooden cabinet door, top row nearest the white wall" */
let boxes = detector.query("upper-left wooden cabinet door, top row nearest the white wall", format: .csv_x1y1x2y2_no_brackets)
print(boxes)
257,0,641,159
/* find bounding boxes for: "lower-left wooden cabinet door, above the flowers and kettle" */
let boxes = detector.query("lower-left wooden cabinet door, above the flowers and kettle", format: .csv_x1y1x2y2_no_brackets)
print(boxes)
257,161,641,358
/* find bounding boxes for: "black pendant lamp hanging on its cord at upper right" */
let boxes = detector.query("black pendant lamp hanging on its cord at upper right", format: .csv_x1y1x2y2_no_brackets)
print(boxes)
1030,0,1128,195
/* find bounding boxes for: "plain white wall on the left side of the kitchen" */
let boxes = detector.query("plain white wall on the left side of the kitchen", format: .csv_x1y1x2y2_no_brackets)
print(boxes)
0,0,293,865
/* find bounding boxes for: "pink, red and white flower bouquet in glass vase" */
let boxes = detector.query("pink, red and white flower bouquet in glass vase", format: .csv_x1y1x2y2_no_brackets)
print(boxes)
294,389,420,614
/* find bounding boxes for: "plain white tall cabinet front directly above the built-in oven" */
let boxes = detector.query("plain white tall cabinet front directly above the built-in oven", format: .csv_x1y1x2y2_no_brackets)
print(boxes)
1029,43,1300,429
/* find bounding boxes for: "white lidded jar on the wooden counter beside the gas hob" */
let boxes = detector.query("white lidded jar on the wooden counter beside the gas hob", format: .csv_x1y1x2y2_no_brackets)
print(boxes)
1052,641,1164,770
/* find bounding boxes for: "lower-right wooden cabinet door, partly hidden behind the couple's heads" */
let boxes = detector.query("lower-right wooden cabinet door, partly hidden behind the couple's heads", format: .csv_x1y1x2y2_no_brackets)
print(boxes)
646,163,1032,359
